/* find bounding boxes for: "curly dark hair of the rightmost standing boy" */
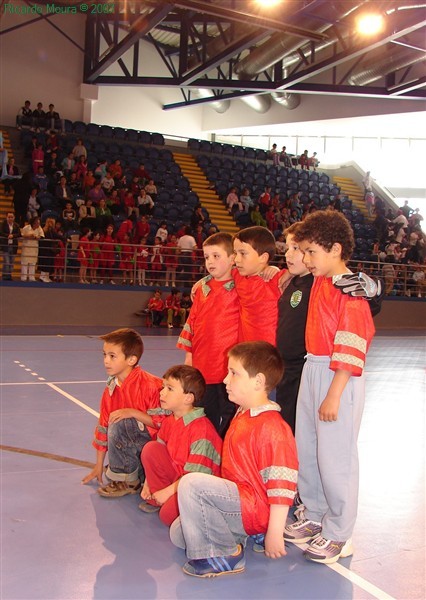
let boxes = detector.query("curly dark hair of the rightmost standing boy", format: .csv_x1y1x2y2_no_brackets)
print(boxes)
294,210,355,261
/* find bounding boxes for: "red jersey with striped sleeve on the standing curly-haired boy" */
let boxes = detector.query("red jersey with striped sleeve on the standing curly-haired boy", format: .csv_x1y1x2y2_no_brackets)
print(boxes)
305,277,375,376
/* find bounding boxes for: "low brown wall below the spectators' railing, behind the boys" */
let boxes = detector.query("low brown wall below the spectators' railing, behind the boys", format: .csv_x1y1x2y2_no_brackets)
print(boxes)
0,284,426,332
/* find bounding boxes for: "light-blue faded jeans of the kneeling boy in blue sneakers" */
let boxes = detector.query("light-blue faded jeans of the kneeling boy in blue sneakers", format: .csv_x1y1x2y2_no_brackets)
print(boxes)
176,473,248,559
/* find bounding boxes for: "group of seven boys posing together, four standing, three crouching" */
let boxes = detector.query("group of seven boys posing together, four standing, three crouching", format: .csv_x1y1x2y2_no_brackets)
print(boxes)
83,211,376,577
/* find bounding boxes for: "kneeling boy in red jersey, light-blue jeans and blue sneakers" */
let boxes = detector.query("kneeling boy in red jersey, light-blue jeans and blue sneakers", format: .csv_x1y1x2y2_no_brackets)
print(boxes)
170,341,298,577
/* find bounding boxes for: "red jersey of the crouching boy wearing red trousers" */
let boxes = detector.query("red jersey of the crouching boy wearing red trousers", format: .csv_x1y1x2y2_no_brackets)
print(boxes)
148,408,222,477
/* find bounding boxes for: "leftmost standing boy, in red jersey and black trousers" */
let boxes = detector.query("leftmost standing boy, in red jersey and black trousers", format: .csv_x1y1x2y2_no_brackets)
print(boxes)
177,232,239,435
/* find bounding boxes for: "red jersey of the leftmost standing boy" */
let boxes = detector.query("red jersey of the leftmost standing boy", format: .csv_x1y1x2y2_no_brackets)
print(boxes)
177,275,240,384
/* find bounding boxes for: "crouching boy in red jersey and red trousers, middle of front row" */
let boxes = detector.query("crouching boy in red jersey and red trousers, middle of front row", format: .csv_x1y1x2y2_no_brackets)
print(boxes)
139,365,222,526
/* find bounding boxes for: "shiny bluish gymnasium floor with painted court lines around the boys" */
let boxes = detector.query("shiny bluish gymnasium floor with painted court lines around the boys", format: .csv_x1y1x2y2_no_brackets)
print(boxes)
0,329,425,600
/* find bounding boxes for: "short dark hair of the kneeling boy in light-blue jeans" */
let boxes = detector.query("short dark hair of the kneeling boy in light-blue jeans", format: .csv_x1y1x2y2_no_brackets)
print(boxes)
228,341,284,392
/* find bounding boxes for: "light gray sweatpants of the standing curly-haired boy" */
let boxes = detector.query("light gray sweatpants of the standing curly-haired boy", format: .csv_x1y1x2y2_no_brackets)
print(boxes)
296,354,365,542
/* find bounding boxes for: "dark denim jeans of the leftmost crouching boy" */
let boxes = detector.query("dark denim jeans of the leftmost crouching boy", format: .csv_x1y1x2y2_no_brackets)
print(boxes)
106,419,151,481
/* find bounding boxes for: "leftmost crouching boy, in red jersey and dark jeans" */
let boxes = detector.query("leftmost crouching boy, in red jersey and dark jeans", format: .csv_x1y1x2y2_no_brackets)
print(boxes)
82,329,162,498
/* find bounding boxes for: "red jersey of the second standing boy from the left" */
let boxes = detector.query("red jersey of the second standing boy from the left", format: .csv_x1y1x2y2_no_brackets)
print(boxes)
232,269,282,346
